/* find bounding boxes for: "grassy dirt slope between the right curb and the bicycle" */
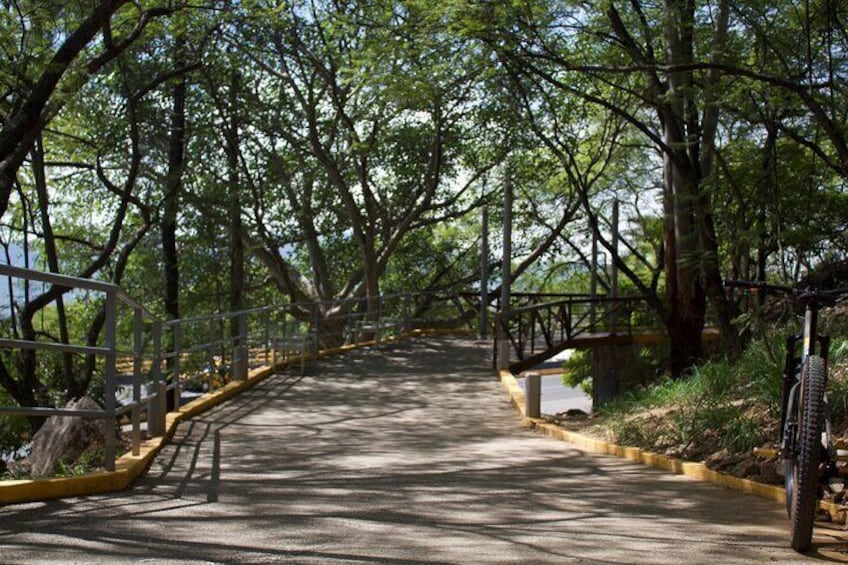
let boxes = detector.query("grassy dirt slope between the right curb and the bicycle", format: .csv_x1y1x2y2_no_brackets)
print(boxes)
588,343,788,460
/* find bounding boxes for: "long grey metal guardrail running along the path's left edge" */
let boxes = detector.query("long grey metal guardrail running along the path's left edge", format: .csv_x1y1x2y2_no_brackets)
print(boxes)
0,265,474,471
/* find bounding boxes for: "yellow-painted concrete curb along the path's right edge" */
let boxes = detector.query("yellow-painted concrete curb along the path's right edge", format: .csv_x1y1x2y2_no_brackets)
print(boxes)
500,370,848,525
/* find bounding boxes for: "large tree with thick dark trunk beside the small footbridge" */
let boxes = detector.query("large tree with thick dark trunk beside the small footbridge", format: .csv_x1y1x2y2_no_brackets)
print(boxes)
464,1,748,375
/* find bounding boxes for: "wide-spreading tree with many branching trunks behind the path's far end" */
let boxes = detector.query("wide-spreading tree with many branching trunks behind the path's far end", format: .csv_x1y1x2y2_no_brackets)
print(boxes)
215,2,504,338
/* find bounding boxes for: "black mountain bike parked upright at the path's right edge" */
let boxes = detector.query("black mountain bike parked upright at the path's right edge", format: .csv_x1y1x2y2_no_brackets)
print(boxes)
725,280,848,553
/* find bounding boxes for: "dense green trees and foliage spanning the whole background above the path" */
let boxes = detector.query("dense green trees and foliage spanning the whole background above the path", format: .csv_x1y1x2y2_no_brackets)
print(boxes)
0,0,848,446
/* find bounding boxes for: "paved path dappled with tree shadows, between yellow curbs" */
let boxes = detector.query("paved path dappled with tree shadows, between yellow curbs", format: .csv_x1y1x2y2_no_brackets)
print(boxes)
0,339,846,564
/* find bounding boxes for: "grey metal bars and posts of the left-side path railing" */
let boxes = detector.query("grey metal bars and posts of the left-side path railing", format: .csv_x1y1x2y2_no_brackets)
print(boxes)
0,265,476,471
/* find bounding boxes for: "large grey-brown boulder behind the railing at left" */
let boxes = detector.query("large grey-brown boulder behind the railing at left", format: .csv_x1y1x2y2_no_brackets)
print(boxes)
28,396,104,477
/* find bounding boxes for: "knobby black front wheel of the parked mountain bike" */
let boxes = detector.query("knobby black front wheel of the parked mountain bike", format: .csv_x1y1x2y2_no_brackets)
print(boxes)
787,355,826,552
